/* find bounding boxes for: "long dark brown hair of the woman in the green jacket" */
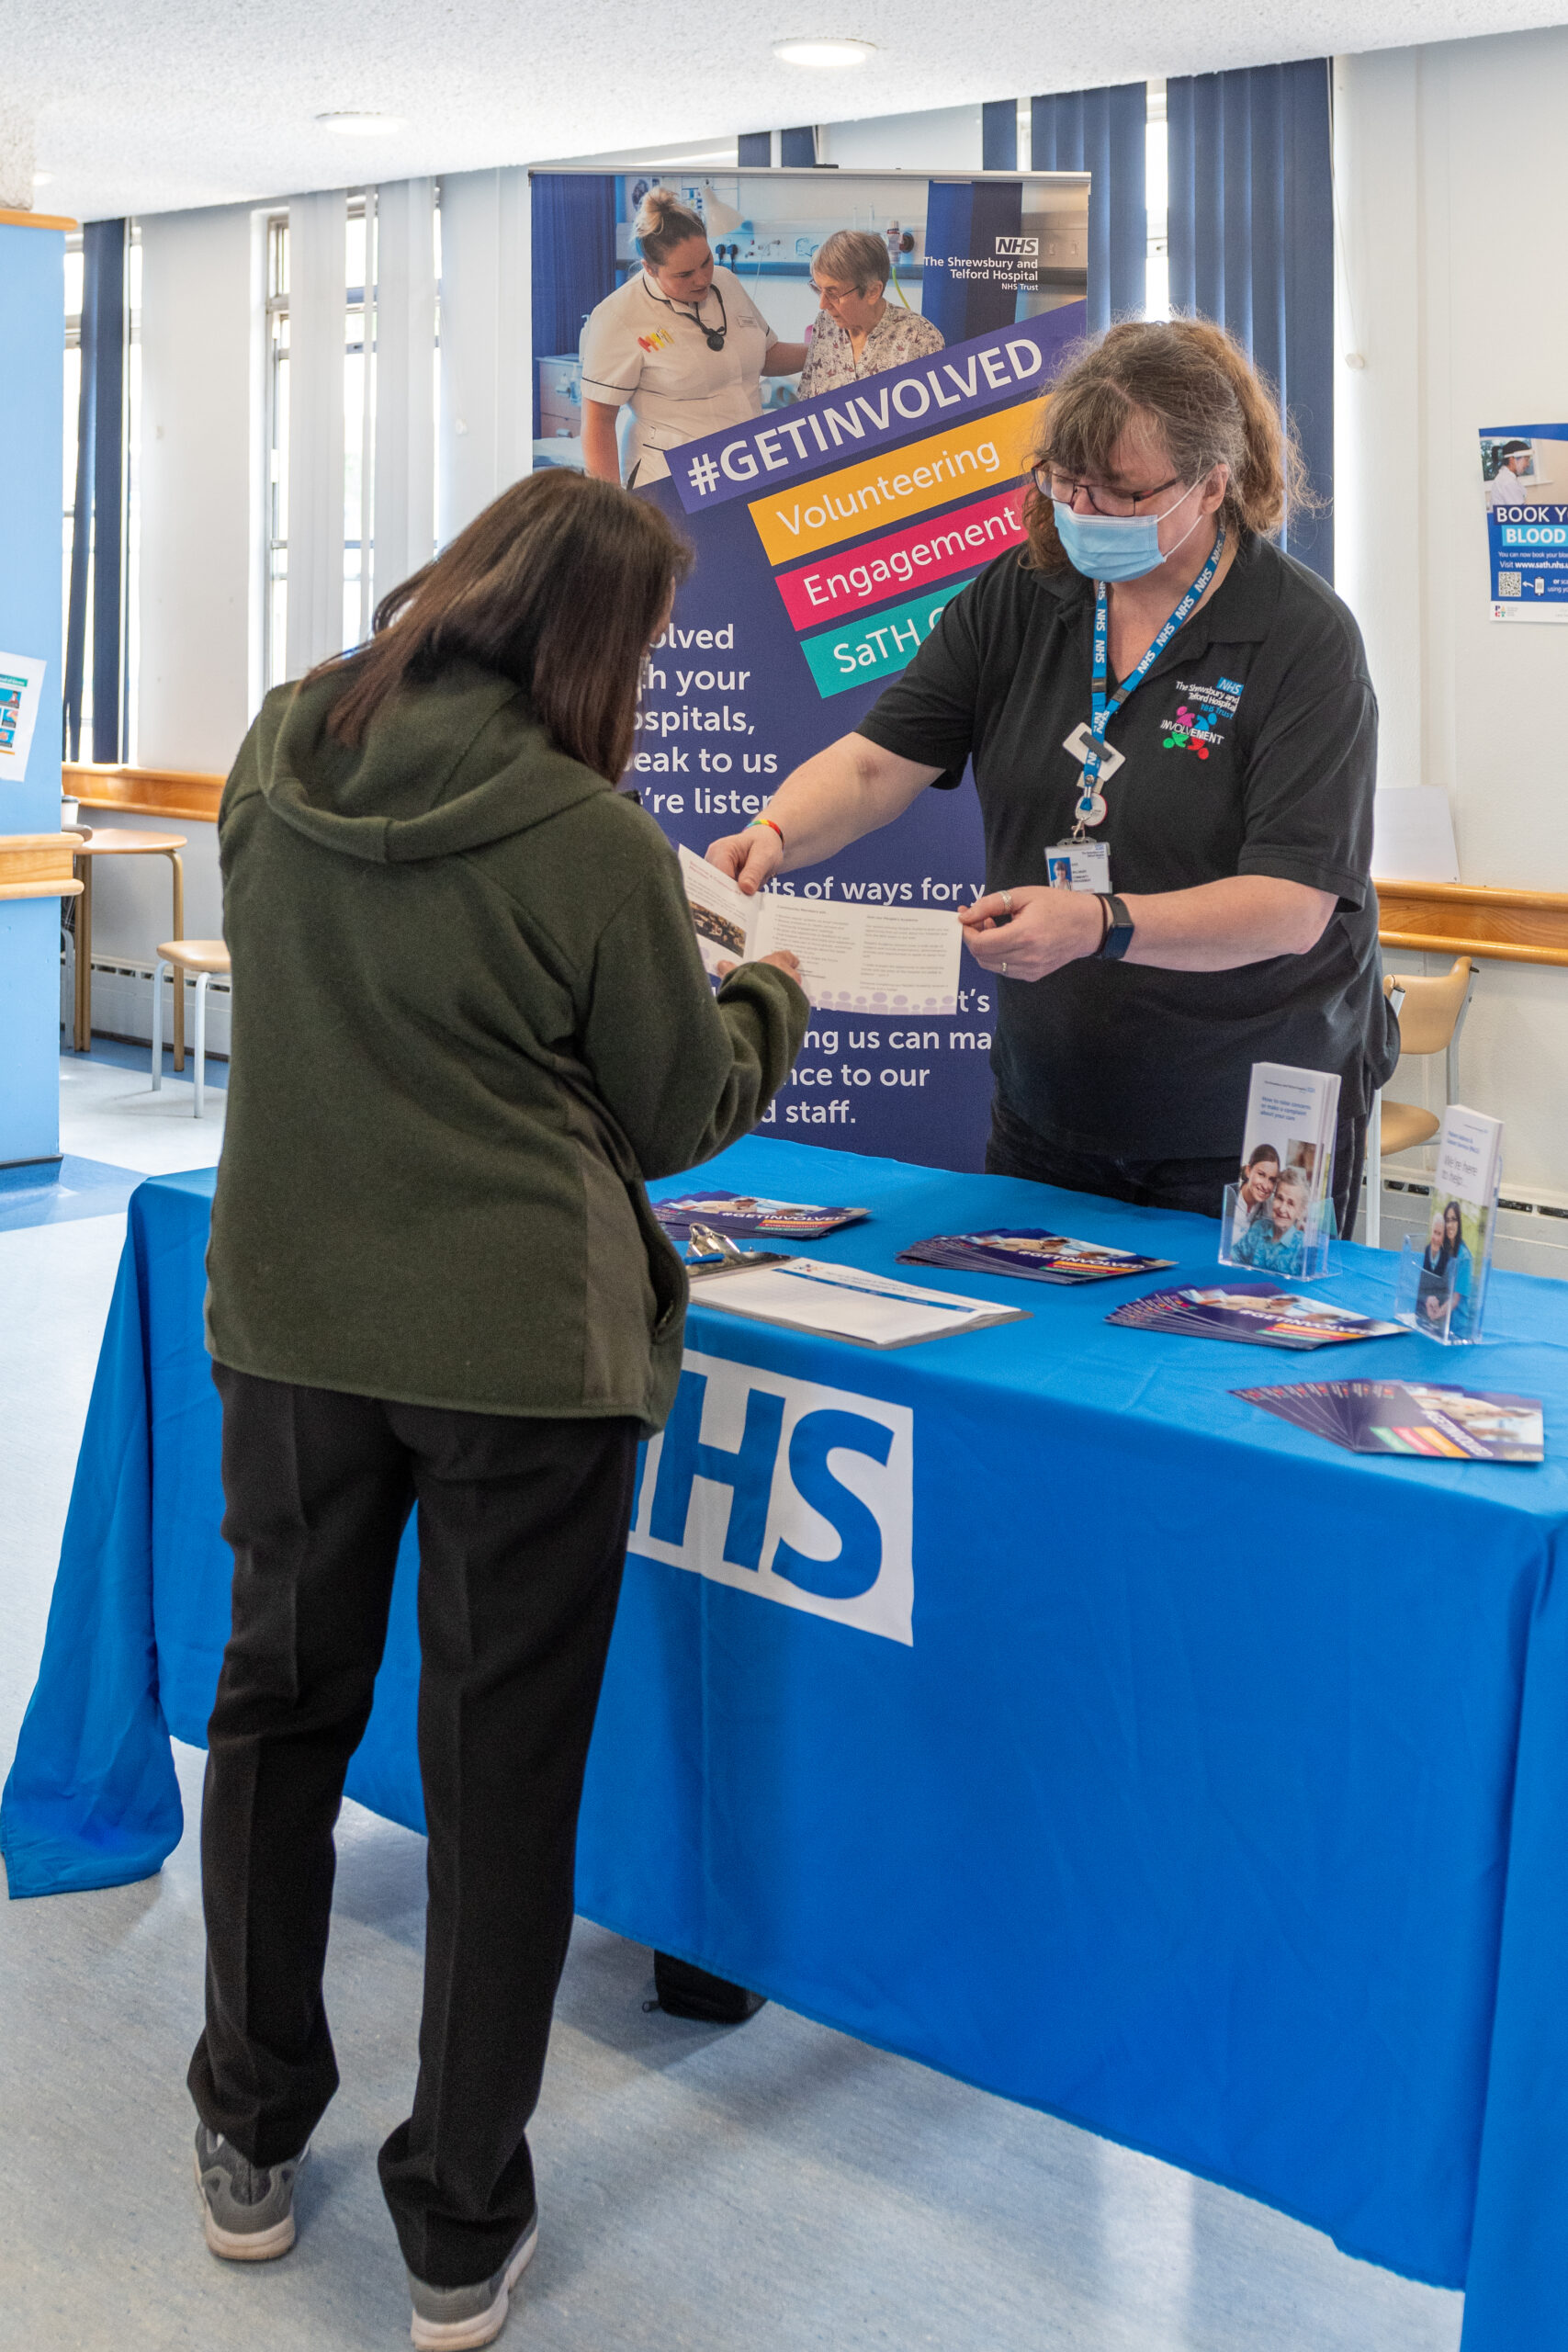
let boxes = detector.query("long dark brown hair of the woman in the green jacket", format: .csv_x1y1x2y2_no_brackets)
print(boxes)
303,466,691,783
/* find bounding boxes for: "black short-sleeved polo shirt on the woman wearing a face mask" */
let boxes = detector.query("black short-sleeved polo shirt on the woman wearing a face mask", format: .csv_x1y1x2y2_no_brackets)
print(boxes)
861,537,1399,1159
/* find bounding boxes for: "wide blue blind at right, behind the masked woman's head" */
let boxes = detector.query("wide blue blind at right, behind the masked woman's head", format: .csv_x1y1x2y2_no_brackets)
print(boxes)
1166,56,1333,581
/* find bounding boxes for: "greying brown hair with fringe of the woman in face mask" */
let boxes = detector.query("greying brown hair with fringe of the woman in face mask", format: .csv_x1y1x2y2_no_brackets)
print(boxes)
1022,318,1319,571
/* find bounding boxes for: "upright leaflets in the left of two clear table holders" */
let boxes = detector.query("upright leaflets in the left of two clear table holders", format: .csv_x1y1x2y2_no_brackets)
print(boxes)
1220,1061,1340,1282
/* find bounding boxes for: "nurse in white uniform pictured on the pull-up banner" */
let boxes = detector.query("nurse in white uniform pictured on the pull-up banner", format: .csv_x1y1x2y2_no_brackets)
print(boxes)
583,188,807,489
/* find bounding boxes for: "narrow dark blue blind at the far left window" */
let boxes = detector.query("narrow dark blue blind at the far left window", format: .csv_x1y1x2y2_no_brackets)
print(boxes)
63,221,125,764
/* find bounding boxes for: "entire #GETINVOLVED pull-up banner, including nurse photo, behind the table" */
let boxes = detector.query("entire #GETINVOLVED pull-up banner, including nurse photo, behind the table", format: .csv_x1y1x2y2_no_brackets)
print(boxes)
534,156,1089,1169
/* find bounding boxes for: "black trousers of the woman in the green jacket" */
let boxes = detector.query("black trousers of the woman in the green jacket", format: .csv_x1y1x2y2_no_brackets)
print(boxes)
190,1366,637,2286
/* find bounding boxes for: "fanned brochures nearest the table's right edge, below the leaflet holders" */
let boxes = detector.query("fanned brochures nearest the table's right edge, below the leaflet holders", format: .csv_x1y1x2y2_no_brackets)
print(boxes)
1235,1381,1547,1463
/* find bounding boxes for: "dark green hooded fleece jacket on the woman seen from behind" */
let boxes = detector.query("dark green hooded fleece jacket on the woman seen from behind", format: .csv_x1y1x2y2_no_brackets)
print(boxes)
207,665,808,1432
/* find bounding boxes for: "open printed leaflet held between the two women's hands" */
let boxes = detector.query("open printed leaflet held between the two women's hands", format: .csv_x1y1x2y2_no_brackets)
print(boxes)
680,849,964,1016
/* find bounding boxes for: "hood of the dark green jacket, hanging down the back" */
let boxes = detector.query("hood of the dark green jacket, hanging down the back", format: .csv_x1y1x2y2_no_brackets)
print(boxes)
256,663,614,865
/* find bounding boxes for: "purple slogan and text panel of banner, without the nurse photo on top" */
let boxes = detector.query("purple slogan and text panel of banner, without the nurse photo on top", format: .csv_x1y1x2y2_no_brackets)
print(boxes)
644,303,1084,1169
